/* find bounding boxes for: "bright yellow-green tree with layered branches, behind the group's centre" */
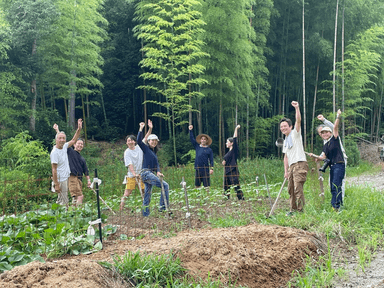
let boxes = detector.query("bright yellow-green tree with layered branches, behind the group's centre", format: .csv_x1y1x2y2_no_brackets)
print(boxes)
135,0,207,164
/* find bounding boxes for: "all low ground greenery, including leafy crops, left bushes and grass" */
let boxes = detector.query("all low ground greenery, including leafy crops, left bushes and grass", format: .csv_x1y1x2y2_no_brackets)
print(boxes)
0,137,384,287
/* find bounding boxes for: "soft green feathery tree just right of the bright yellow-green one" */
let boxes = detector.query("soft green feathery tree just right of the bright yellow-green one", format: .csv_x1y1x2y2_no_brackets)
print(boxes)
201,0,262,157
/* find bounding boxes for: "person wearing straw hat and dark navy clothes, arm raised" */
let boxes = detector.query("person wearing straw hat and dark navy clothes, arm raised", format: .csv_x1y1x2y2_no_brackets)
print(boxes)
188,125,213,194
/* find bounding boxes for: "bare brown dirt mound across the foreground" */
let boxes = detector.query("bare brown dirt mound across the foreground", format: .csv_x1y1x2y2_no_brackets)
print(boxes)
0,224,326,288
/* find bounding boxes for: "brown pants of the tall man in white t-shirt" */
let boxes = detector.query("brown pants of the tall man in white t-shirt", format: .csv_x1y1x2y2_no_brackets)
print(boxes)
288,161,308,212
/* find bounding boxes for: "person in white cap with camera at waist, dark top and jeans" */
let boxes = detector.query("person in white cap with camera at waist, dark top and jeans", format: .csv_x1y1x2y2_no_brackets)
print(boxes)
316,109,345,211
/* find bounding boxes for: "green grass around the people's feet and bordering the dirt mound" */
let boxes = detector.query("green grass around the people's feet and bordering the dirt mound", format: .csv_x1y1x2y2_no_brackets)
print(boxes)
2,140,384,287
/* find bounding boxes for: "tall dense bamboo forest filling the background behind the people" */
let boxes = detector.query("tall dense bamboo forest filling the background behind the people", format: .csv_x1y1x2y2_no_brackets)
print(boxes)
0,0,384,160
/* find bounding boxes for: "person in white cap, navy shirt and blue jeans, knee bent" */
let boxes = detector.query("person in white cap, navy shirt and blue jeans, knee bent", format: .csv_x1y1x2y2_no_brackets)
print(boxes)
137,121,169,217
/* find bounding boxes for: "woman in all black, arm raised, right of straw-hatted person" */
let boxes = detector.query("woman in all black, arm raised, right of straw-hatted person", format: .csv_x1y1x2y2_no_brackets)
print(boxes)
222,125,244,200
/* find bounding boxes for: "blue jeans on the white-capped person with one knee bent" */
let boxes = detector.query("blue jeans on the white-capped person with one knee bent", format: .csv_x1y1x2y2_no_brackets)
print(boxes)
140,170,169,216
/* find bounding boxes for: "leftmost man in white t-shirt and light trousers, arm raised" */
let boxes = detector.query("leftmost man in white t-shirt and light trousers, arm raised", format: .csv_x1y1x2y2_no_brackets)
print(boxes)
51,119,83,207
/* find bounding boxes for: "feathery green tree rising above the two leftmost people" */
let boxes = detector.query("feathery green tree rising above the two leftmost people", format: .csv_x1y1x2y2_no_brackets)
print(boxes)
44,0,107,129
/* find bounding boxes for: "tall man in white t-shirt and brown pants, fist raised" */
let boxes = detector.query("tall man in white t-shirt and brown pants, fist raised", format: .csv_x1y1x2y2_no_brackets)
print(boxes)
280,101,308,216
